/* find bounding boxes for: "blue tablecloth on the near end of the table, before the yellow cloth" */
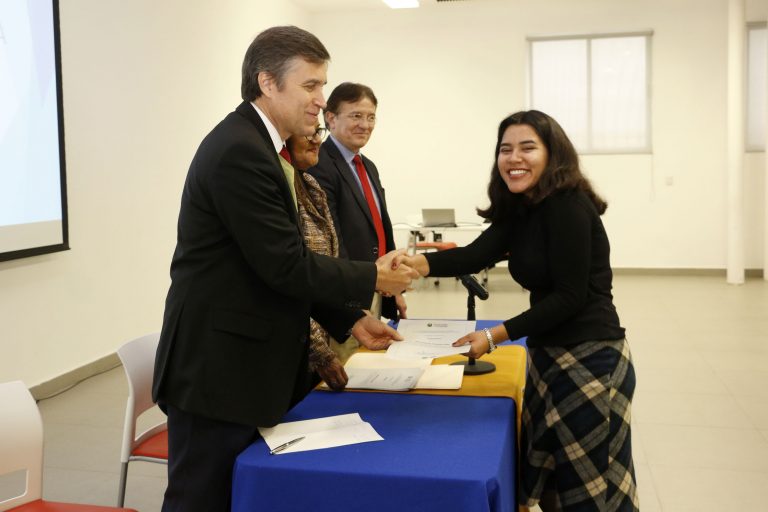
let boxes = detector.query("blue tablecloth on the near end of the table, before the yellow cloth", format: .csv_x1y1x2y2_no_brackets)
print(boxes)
232,391,516,512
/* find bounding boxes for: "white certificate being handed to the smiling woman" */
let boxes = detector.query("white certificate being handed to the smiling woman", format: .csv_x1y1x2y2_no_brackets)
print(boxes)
387,319,475,359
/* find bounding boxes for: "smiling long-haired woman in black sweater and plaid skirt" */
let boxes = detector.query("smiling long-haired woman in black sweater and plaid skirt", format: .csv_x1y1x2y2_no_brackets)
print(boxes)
403,110,639,512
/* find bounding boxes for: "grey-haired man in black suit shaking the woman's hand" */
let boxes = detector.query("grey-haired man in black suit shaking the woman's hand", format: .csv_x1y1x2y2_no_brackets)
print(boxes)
152,27,415,512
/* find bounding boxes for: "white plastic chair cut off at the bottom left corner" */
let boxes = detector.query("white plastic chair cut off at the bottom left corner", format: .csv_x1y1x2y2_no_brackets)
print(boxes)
0,380,136,512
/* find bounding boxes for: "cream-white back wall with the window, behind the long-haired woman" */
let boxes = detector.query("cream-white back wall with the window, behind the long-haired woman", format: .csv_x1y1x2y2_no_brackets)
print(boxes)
310,0,768,269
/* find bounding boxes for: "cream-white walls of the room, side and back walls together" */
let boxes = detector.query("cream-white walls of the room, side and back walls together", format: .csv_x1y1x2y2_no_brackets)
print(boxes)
0,0,768,386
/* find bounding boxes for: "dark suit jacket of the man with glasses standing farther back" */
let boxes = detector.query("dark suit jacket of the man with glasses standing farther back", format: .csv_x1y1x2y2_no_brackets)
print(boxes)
308,138,397,320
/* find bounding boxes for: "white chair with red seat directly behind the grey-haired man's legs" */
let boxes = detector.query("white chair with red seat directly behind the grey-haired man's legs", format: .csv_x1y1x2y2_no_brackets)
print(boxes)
117,333,168,507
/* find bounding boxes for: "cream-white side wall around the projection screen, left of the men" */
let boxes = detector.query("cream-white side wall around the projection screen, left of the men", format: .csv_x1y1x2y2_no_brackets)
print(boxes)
0,0,306,386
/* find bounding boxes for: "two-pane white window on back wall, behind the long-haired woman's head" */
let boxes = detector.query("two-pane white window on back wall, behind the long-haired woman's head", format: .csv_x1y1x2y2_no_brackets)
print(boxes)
529,33,651,153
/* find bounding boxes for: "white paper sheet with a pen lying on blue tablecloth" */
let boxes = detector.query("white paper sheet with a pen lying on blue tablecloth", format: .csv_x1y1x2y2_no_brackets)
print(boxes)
259,413,384,455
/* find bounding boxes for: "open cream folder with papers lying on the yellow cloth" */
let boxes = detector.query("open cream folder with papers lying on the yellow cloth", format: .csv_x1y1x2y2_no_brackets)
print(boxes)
323,352,464,391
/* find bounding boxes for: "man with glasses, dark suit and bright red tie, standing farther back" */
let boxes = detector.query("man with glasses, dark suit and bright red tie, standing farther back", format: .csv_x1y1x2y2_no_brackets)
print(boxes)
309,82,406,328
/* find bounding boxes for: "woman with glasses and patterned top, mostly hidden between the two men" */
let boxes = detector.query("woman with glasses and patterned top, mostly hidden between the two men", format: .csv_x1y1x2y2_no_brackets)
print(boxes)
286,123,348,390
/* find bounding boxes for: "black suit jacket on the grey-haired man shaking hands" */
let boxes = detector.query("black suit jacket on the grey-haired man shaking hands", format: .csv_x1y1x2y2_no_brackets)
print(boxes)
152,102,376,426
